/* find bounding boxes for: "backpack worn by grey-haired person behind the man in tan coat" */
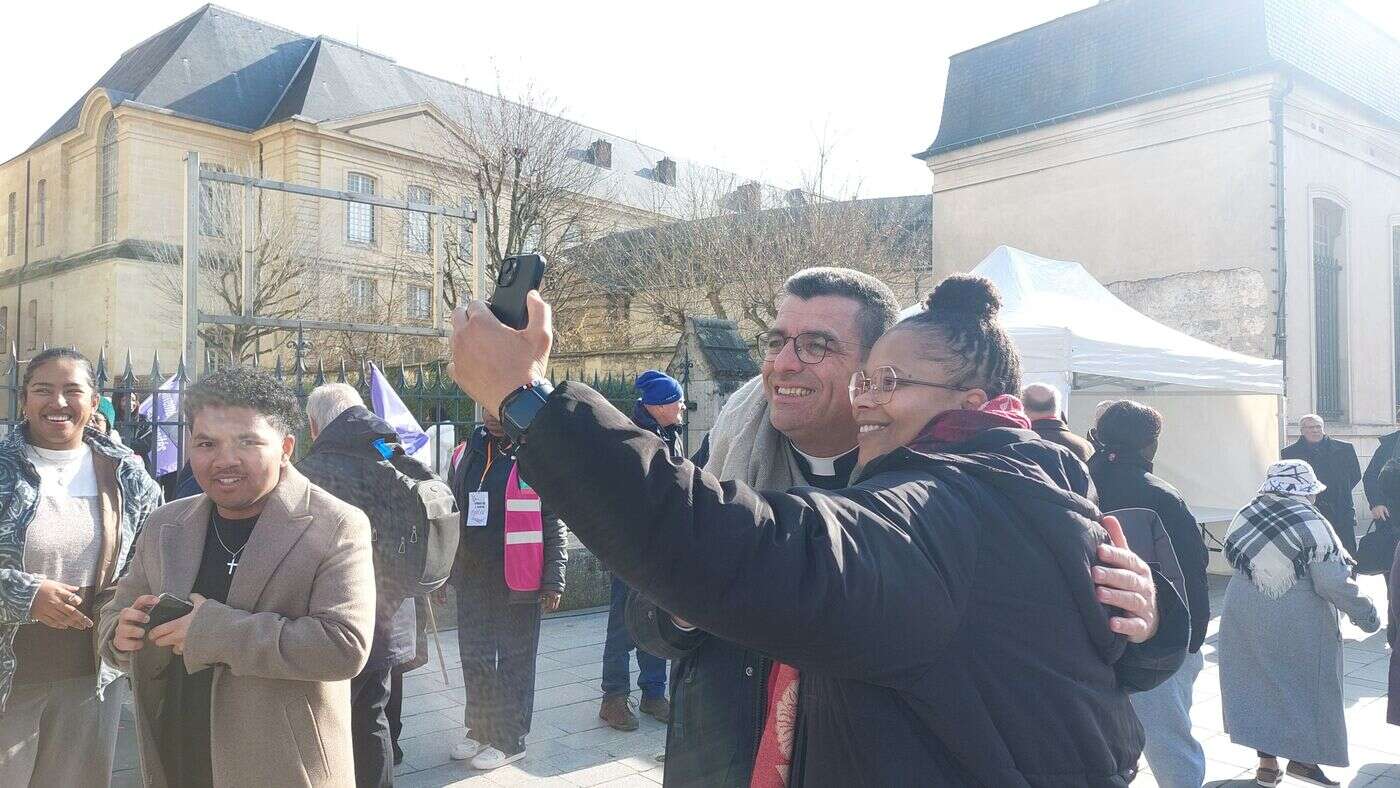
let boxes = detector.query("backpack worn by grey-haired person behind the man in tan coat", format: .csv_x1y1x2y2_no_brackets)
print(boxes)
308,439,461,599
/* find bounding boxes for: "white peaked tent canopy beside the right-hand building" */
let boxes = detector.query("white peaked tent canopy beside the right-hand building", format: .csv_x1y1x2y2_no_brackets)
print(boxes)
900,246,1284,395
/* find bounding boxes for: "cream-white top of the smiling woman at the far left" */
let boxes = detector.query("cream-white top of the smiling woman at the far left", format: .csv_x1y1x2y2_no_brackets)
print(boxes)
24,444,102,588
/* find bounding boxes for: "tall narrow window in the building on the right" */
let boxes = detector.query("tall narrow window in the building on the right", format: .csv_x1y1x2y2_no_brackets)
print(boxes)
1313,199,1347,420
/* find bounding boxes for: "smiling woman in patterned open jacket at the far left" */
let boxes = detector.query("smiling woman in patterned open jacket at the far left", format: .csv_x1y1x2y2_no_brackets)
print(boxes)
0,349,160,787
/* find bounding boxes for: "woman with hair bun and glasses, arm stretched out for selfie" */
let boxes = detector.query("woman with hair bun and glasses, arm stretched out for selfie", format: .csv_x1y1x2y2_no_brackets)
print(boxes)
452,277,1186,787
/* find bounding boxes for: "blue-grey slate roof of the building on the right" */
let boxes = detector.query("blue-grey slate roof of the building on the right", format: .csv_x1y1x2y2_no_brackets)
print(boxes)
918,0,1400,158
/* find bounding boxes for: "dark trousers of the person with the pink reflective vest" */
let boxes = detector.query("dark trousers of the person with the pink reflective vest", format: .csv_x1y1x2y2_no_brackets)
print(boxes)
455,575,539,754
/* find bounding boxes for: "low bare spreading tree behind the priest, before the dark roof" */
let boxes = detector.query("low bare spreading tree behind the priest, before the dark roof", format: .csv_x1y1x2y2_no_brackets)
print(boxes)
557,146,931,343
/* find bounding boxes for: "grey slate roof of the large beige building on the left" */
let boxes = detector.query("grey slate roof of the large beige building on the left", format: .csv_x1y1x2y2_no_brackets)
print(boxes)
31,6,734,210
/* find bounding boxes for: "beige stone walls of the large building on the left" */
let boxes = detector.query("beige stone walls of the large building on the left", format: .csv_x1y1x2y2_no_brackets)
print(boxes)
0,90,662,374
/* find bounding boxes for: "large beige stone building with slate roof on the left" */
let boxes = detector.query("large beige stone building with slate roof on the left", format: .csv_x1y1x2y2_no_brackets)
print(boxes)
0,6,733,368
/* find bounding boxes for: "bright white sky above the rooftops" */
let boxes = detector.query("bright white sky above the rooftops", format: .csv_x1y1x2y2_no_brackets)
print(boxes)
0,0,1400,196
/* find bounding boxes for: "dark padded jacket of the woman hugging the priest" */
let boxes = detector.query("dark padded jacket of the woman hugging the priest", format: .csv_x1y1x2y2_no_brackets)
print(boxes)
519,384,1142,787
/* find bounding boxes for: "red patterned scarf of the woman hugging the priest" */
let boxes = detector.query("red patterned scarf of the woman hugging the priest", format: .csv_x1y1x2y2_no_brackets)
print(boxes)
749,395,1030,788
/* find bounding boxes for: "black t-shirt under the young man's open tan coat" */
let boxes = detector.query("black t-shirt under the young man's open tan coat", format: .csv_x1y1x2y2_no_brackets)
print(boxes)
160,509,258,788
